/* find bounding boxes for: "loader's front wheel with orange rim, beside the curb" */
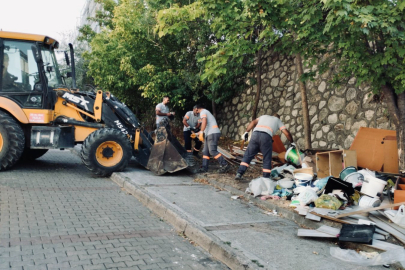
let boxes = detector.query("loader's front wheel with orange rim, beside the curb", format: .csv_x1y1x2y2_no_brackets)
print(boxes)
81,128,132,176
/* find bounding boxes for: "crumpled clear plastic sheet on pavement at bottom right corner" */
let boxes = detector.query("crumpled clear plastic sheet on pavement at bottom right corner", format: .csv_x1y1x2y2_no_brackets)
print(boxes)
330,247,405,266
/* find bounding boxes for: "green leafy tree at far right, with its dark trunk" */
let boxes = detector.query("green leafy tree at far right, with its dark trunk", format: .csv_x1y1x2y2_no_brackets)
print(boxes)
306,0,405,170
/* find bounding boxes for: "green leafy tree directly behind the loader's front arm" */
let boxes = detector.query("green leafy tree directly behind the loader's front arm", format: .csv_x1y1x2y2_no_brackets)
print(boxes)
81,0,246,124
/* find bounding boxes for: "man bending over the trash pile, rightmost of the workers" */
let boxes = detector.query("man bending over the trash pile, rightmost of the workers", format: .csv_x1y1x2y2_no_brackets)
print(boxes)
235,114,294,180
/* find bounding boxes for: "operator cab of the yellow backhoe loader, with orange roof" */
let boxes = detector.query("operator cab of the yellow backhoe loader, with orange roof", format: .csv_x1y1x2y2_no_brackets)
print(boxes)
0,31,65,109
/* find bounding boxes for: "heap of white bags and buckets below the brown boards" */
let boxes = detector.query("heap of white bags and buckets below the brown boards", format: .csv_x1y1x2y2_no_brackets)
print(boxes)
246,148,401,213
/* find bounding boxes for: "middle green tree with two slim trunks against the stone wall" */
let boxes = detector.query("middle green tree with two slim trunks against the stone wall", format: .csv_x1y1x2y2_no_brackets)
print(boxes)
158,0,311,148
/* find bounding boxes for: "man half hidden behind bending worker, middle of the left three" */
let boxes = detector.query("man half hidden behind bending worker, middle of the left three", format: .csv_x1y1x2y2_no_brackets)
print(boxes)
183,106,202,157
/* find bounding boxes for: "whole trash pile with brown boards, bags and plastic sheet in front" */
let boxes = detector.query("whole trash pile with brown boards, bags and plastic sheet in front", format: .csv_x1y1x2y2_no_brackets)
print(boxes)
238,128,405,268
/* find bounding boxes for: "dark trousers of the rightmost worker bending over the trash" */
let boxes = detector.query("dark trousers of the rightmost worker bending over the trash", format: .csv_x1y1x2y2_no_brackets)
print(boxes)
238,131,273,178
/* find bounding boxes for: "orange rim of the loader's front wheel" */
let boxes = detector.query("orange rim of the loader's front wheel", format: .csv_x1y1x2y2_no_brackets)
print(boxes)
96,141,124,167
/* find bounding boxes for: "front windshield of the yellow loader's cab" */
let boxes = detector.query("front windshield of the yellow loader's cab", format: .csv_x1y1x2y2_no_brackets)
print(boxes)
41,46,64,88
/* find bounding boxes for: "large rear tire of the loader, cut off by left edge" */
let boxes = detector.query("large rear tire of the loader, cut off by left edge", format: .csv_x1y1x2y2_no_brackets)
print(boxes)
0,111,25,170
